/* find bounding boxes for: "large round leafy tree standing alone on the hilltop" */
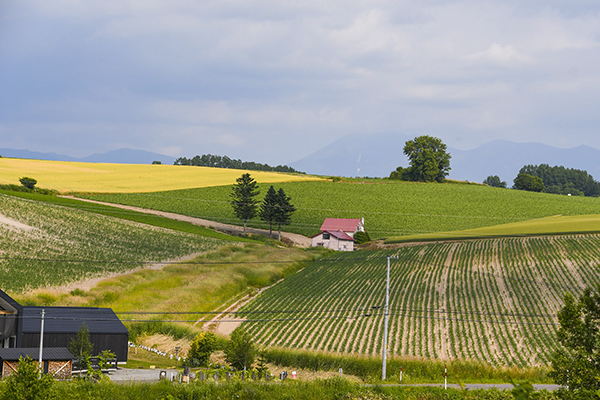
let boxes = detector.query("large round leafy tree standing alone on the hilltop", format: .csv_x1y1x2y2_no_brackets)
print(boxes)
402,135,451,182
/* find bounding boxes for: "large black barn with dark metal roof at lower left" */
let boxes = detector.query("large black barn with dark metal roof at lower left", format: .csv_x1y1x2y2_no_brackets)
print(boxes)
0,290,129,362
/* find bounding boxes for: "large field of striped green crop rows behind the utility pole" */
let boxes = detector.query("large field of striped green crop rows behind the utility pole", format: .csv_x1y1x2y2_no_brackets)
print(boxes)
243,235,600,366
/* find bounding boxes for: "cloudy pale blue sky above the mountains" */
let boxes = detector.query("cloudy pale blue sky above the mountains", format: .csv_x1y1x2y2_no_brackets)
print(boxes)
0,0,600,165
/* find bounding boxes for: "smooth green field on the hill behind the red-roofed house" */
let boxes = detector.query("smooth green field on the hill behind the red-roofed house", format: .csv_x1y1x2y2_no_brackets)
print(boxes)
85,180,600,238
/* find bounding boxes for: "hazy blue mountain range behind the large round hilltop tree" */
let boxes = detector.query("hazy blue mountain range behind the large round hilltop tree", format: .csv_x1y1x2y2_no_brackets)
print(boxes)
289,133,600,186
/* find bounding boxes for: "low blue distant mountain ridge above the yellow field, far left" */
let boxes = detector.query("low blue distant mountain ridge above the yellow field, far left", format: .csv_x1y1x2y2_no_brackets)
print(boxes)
0,149,175,165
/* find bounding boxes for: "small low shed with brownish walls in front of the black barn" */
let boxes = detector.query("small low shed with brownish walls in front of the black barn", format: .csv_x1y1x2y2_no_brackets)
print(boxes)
0,347,75,379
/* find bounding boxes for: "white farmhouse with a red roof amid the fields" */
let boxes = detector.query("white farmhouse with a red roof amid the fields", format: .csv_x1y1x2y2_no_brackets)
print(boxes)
311,218,365,251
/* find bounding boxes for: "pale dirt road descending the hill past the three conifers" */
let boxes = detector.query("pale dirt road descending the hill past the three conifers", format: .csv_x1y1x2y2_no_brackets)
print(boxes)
61,196,311,247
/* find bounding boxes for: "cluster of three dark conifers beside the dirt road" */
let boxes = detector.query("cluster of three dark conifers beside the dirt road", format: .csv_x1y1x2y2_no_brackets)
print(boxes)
231,173,296,240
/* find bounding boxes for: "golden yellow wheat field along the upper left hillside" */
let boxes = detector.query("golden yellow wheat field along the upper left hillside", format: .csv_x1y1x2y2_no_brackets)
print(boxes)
0,158,320,193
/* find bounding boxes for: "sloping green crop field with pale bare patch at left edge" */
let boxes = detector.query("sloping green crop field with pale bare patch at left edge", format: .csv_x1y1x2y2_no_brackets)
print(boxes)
0,194,228,293
